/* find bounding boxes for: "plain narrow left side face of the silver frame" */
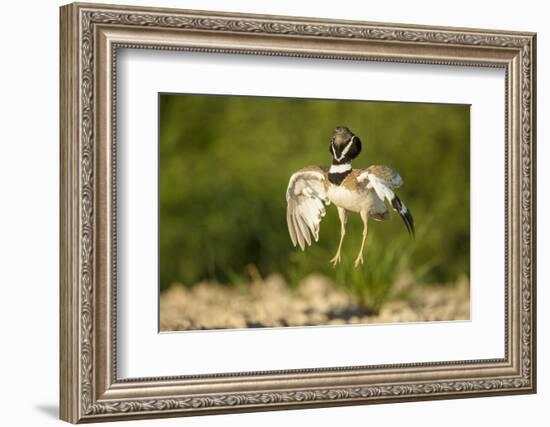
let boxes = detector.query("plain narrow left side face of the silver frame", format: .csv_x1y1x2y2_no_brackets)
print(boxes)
59,5,80,423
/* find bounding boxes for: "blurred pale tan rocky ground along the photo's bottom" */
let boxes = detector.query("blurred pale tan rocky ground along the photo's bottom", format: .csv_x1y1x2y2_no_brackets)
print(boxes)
160,275,470,331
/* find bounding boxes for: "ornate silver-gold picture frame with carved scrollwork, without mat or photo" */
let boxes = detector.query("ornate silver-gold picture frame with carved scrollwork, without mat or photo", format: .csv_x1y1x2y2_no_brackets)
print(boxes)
60,4,536,423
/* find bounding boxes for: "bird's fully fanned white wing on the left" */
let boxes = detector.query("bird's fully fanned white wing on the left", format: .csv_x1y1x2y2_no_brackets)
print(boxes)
286,166,329,250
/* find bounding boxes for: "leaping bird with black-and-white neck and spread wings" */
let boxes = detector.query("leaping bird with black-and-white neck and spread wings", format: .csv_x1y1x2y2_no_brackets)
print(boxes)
286,126,415,268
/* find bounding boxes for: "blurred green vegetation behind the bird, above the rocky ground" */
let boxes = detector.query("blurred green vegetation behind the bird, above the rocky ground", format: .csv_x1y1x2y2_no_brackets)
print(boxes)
160,94,470,308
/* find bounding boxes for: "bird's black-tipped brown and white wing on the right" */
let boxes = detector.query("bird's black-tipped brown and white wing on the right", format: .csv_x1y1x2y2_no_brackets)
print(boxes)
357,165,414,237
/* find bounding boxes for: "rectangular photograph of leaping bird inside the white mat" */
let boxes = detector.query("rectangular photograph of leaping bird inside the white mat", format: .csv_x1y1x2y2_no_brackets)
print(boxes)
158,93,470,332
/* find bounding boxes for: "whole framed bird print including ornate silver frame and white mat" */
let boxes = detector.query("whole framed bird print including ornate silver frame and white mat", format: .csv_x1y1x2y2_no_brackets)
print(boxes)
60,4,536,423
